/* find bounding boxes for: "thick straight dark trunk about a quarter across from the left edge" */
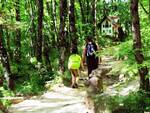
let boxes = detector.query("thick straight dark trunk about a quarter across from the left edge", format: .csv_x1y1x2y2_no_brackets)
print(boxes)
36,0,43,62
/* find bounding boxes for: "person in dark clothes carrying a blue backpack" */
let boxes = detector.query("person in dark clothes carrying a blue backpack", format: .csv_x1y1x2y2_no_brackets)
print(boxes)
82,37,99,77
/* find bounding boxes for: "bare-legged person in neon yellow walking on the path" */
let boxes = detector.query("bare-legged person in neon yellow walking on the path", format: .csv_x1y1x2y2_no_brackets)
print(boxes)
68,48,83,88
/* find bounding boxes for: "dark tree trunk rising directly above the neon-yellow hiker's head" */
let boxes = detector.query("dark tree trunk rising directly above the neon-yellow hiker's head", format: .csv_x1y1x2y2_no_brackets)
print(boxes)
69,0,77,49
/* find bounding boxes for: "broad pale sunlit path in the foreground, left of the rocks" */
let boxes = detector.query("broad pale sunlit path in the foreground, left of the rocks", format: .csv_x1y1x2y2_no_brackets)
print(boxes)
9,86,94,113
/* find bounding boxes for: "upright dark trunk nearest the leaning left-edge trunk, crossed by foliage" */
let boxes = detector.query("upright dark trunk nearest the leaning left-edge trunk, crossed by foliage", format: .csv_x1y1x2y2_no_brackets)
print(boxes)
14,0,21,63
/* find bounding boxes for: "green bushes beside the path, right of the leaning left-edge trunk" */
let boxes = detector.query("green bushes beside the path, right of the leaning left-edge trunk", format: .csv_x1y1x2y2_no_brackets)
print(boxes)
11,57,55,95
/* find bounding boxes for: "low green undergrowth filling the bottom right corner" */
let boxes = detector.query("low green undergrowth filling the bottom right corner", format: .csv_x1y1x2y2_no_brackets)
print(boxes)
95,92,150,113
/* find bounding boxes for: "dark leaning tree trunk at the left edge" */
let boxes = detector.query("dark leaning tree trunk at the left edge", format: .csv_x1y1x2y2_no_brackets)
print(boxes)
0,25,14,90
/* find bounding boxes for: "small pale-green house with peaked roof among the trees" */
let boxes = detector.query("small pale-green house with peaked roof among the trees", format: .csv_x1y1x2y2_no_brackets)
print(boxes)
99,16,120,37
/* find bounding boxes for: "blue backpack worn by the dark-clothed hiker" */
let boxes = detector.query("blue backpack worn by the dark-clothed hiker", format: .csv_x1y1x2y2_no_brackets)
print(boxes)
86,43,97,56
